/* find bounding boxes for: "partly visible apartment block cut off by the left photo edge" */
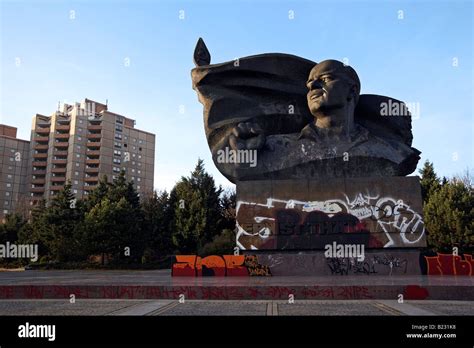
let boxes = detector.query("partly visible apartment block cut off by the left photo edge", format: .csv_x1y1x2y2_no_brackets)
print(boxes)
0,124,30,221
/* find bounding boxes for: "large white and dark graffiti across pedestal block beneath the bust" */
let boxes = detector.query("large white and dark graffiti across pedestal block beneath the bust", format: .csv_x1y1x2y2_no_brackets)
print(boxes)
236,193,425,250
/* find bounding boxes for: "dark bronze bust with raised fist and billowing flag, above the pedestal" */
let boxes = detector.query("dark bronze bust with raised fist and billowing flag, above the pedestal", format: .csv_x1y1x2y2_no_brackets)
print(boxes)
191,39,420,183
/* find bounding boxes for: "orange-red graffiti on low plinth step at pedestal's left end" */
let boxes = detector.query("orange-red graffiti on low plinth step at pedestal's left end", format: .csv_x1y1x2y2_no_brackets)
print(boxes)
171,255,272,277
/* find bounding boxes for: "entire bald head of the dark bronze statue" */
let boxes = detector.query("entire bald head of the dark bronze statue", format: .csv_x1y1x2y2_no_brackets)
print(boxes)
306,59,360,128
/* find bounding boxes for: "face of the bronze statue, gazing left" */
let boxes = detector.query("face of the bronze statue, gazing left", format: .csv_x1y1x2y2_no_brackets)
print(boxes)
306,60,354,116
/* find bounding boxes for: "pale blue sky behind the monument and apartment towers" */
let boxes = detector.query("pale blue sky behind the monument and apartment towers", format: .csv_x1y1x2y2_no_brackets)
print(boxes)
0,0,474,189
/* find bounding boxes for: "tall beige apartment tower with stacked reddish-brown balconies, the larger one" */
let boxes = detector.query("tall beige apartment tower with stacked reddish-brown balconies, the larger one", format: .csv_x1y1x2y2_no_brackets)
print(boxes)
28,99,155,204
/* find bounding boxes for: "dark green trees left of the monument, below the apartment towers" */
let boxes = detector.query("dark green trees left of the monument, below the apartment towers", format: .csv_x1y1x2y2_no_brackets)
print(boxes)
0,160,235,265
